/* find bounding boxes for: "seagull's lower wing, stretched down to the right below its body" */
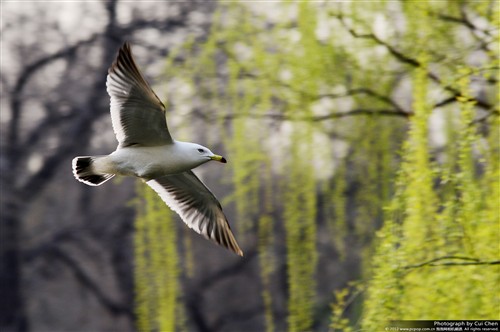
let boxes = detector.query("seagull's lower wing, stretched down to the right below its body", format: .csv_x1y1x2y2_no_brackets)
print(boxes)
147,171,243,256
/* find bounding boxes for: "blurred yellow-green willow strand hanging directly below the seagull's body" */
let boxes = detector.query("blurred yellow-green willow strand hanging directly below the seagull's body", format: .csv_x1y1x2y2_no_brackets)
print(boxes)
134,181,180,331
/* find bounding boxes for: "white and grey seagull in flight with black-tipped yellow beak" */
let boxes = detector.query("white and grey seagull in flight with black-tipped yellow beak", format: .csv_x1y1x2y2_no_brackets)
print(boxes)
72,43,243,256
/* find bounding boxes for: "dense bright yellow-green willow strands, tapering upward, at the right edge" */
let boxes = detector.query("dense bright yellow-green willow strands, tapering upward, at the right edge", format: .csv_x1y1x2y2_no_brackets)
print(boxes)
362,2,500,330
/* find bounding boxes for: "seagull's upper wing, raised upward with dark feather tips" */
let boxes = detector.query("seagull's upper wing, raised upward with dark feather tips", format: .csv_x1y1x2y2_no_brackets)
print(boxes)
106,43,172,147
